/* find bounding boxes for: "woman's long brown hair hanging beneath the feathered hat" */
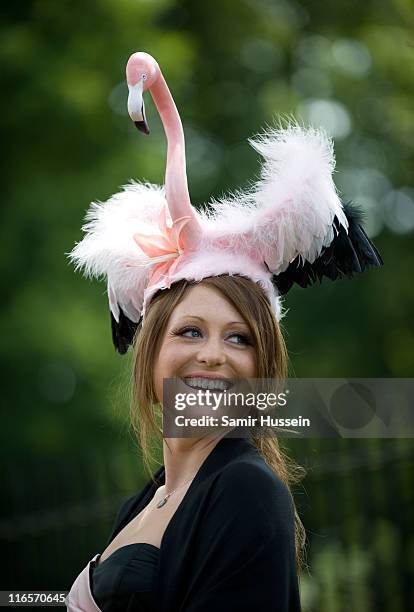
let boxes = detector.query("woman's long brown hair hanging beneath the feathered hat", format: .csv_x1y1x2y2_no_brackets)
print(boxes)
131,275,306,569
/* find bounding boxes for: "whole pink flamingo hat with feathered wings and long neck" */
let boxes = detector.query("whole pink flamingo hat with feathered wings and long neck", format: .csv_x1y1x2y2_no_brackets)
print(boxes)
68,53,383,354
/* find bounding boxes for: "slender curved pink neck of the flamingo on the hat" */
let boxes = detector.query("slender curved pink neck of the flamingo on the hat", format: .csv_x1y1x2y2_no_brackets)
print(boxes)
150,72,199,249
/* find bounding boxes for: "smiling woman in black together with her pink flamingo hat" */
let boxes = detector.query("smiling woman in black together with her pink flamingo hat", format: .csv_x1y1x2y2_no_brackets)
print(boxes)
68,53,382,612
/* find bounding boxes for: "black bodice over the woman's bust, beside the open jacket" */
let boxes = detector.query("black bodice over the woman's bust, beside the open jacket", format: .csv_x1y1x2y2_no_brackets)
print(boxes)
89,543,160,612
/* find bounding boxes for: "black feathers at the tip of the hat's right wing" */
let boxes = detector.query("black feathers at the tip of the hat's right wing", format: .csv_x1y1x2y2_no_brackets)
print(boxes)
272,202,384,295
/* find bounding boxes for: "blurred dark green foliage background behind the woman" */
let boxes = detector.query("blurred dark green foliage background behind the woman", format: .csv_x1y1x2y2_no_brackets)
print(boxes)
0,0,414,612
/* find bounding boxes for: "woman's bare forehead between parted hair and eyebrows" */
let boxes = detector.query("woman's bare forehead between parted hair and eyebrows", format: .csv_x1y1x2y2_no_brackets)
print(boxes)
170,285,244,322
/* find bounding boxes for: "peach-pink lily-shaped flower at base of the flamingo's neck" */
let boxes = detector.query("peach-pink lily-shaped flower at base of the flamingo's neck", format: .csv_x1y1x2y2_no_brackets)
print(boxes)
133,205,191,287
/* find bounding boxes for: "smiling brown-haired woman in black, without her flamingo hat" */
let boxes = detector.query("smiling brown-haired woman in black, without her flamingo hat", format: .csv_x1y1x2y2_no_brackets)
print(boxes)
68,276,304,612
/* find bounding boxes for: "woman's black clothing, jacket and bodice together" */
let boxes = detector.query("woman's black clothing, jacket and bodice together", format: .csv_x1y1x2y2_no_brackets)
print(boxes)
98,436,301,612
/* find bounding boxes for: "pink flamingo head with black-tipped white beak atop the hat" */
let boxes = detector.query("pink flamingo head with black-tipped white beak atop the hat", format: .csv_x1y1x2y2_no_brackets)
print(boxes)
126,52,160,134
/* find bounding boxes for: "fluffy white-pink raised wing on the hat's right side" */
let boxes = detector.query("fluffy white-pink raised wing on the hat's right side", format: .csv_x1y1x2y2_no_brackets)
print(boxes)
204,124,348,274
